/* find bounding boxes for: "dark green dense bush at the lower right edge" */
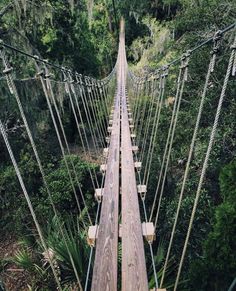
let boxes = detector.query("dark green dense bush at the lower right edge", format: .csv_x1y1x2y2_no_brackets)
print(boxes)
190,160,236,291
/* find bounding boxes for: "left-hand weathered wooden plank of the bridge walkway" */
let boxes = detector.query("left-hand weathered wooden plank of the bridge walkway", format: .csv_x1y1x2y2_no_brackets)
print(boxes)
91,88,120,291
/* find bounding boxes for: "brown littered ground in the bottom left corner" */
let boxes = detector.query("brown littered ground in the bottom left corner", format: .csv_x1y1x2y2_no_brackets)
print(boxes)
0,235,30,291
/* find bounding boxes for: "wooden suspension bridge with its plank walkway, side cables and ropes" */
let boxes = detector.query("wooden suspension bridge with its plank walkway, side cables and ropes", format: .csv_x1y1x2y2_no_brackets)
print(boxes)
0,13,236,291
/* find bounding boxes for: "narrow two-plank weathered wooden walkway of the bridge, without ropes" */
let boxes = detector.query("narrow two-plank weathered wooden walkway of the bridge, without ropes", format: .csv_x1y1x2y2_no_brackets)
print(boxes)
91,18,148,291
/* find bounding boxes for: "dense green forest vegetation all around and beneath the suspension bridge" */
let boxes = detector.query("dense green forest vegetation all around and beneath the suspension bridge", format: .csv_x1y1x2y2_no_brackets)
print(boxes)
0,0,236,291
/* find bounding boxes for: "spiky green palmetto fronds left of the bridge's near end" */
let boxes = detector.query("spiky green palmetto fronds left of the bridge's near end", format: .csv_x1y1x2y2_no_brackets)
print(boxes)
8,216,90,290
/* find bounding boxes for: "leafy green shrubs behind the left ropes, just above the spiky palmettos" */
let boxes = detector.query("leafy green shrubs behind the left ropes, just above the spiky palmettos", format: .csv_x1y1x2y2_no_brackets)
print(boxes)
0,151,95,233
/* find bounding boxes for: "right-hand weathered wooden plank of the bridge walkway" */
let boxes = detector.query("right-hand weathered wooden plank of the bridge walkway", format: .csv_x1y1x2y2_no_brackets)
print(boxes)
120,22,148,291
